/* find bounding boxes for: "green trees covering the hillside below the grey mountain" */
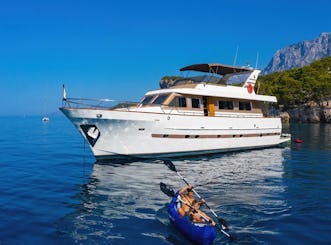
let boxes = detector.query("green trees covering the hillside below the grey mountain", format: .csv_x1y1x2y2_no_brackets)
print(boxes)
258,57,331,108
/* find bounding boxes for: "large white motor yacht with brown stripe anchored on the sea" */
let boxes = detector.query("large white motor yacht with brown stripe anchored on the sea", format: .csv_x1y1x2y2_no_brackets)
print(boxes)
60,64,290,160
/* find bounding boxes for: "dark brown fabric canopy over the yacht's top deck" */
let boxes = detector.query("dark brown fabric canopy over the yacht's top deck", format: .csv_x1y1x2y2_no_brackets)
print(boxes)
180,64,253,76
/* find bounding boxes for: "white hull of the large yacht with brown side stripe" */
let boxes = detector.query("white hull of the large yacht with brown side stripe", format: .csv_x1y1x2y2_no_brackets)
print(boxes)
61,107,289,160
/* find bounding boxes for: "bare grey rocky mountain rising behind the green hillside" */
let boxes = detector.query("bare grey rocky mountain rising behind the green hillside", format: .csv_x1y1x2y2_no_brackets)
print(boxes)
262,32,331,74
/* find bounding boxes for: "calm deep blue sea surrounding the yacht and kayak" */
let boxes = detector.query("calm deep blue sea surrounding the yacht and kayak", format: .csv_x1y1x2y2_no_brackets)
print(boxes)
0,116,331,244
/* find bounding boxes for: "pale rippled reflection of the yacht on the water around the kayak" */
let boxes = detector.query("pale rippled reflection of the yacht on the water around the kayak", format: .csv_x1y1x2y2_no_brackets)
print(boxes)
59,148,288,244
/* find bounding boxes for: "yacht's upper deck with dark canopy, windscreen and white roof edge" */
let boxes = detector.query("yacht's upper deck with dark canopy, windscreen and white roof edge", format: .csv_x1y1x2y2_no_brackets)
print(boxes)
146,64,277,102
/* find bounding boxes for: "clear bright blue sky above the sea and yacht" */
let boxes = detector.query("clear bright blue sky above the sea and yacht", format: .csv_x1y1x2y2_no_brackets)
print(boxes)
0,0,331,116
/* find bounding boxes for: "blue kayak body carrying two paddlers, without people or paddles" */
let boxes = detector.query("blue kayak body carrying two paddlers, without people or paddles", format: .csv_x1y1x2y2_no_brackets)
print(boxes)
168,192,216,245
